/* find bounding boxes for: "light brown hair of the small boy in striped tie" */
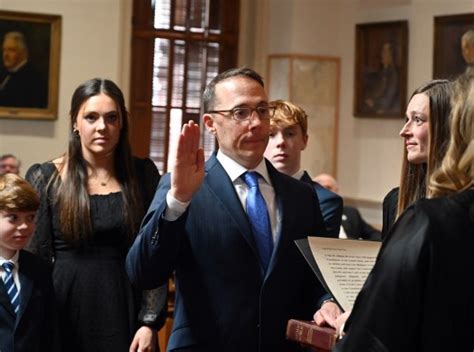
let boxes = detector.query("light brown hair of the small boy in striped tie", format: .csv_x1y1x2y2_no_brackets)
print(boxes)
0,174,40,211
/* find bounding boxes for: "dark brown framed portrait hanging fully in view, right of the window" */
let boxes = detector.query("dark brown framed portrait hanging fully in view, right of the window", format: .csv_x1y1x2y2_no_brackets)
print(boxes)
354,21,408,118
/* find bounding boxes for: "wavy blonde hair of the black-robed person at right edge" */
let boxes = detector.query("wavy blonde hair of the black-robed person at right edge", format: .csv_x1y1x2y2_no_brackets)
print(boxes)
429,75,474,197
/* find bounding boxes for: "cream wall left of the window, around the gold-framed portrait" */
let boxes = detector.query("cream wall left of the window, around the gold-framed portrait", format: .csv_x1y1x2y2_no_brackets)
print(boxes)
0,0,131,174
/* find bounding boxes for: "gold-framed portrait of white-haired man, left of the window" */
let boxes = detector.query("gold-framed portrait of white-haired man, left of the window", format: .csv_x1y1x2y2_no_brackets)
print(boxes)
0,11,61,119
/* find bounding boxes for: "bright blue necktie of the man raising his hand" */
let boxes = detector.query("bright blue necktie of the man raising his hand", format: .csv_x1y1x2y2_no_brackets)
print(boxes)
243,171,273,271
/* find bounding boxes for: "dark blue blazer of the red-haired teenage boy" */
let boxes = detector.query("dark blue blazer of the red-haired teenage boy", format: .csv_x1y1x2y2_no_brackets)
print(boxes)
300,171,343,237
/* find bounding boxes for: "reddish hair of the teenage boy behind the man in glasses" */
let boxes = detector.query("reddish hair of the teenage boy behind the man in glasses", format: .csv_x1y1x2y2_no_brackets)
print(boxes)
270,100,308,136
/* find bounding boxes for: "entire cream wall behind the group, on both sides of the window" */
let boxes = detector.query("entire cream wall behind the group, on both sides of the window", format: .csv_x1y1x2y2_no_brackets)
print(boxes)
0,0,474,222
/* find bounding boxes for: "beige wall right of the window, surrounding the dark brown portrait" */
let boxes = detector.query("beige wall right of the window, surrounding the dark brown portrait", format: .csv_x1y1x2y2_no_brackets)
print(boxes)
258,0,474,206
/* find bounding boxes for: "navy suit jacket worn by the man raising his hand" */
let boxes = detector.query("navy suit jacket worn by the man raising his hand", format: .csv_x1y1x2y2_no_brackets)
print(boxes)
126,155,334,352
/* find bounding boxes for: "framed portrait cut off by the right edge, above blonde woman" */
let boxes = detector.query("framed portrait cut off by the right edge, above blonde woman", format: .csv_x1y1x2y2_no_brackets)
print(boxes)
433,13,474,79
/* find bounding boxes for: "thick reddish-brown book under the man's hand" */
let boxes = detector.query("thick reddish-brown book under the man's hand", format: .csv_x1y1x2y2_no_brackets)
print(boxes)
286,319,338,351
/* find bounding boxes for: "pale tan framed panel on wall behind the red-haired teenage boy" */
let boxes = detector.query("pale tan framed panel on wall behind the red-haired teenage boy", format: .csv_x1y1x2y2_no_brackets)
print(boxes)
267,54,341,177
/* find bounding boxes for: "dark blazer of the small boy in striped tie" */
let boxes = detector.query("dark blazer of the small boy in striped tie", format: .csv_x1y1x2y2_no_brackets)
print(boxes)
0,250,58,352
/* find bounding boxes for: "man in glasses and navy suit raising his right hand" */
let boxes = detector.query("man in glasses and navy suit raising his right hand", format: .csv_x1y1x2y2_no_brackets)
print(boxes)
126,68,334,352
